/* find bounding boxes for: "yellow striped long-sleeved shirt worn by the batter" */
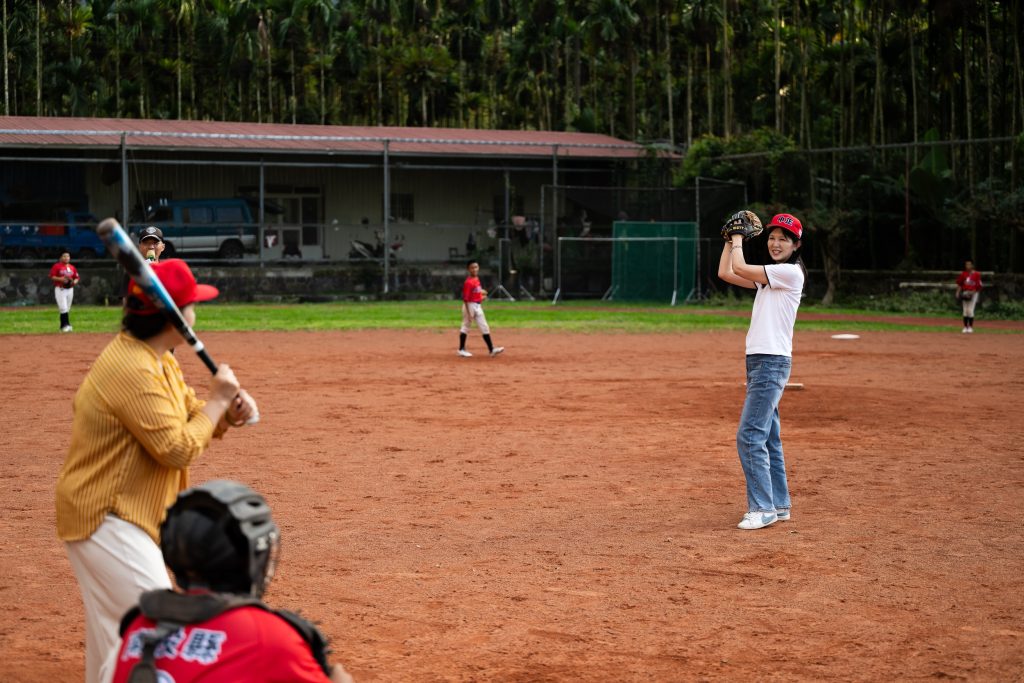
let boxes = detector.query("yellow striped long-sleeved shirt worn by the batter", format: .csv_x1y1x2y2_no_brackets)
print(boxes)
56,332,220,544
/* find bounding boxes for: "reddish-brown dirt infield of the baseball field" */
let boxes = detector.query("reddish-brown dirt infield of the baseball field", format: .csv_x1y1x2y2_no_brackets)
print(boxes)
0,327,1024,683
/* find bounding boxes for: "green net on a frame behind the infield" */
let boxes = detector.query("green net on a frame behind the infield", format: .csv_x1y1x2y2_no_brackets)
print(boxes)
608,221,697,301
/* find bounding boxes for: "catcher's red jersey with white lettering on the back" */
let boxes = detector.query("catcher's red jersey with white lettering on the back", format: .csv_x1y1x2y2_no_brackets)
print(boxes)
113,607,330,683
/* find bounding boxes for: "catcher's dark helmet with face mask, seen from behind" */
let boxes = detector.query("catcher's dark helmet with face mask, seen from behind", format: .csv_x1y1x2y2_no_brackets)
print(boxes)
160,479,281,597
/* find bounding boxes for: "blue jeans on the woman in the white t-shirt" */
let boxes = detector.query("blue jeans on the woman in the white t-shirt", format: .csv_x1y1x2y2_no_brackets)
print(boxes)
736,353,793,512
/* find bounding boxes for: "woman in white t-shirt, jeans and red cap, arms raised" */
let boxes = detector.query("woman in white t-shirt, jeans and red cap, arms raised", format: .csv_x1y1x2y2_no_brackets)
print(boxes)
718,213,807,529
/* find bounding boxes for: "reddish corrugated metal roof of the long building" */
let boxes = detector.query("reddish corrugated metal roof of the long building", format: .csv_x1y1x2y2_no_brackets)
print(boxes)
0,117,644,159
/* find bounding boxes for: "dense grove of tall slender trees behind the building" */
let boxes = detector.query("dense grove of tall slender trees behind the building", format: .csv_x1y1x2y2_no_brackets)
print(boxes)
0,0,1024,274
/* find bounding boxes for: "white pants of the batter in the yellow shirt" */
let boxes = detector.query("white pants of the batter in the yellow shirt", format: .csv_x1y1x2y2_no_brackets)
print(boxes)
66,511,171,683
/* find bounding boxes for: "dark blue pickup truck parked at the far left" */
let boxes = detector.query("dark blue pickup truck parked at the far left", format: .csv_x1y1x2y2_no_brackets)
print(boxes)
0,211,106,260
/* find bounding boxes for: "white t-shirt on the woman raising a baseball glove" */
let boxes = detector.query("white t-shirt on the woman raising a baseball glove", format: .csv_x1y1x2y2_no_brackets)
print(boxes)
746,263,804,356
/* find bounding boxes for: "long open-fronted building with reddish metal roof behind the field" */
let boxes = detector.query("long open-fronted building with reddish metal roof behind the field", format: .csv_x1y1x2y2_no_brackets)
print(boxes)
0,117,663,288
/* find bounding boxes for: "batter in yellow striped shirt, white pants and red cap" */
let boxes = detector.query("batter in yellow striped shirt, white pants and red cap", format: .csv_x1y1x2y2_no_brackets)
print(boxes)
55,259,258,683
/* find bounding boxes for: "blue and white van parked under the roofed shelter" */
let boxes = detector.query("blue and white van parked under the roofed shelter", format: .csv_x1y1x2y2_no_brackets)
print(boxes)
129,198,259,260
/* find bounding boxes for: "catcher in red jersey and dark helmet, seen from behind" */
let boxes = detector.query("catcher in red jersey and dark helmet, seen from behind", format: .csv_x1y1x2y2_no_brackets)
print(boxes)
102,480,352,683
